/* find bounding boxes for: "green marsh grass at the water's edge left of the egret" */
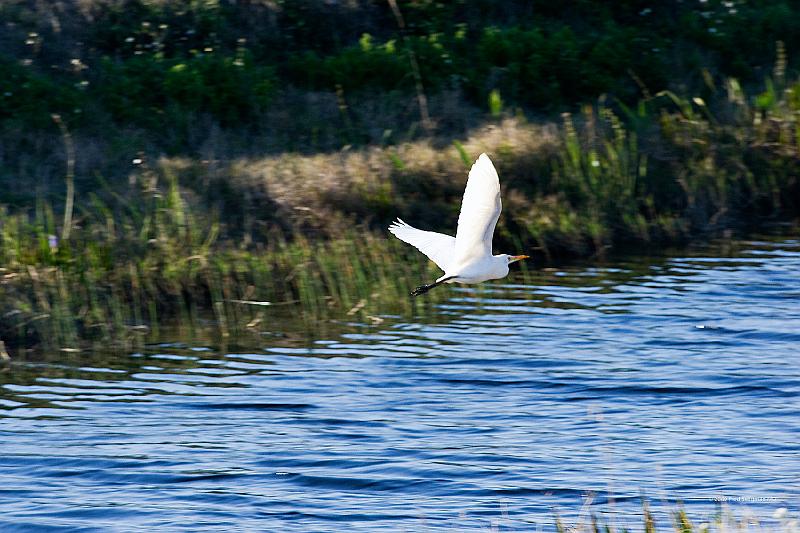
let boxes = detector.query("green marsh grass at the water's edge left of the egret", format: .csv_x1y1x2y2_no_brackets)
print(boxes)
0,167,444,348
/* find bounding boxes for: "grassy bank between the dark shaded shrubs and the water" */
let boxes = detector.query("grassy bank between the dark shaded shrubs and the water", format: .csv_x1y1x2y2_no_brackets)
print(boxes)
0,61,800,354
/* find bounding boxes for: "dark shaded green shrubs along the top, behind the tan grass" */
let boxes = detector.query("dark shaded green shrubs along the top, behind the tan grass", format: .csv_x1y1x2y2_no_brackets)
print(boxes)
0,0,800,156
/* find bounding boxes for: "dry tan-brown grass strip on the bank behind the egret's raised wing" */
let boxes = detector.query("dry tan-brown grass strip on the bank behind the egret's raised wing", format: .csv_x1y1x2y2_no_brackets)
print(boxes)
159,118,559,237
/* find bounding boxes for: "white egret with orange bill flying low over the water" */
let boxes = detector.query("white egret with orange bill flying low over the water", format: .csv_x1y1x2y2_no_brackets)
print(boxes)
389,154,528,296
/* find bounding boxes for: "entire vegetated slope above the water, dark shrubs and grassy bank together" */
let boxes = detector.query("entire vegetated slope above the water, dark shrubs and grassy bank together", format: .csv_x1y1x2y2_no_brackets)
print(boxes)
0,0,800,348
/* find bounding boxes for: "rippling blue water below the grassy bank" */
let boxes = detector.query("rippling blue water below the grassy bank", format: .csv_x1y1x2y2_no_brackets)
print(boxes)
0,240,800,531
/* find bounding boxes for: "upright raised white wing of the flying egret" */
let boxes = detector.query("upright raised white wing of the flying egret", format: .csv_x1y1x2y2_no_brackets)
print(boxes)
455,154,502,260
